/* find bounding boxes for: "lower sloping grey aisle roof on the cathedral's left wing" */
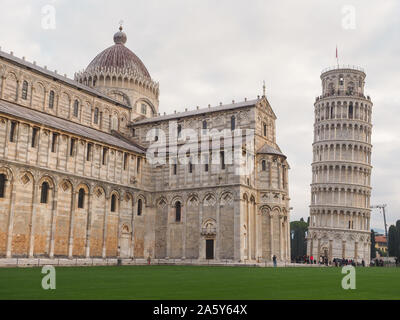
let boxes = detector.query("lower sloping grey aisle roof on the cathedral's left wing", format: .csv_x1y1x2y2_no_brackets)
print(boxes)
0,100,144,153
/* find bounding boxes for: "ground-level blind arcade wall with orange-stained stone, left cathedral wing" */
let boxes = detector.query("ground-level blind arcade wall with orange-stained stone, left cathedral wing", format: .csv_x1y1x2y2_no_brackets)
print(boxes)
0,166,146,257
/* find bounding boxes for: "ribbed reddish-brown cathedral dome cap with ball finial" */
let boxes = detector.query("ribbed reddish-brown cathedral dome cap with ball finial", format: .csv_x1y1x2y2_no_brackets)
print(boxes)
85,27,150,79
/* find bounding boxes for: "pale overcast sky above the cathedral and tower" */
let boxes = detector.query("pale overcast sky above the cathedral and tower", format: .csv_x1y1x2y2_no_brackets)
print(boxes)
0,0,400,229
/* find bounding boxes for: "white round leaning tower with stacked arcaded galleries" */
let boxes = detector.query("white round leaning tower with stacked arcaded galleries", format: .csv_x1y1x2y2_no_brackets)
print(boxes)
307,66,372,264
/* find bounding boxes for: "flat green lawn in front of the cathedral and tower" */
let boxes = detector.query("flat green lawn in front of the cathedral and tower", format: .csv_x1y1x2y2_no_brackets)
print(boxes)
0,266,400,300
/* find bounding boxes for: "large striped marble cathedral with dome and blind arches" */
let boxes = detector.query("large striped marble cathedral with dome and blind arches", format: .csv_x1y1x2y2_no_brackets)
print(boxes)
0,28,290,262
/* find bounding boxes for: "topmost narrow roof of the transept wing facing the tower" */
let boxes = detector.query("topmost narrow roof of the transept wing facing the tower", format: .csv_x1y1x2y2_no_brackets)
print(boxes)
131,99,260,126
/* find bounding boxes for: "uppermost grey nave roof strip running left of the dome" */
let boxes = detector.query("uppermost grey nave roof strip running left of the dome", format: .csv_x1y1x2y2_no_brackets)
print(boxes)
0,50,130,108
